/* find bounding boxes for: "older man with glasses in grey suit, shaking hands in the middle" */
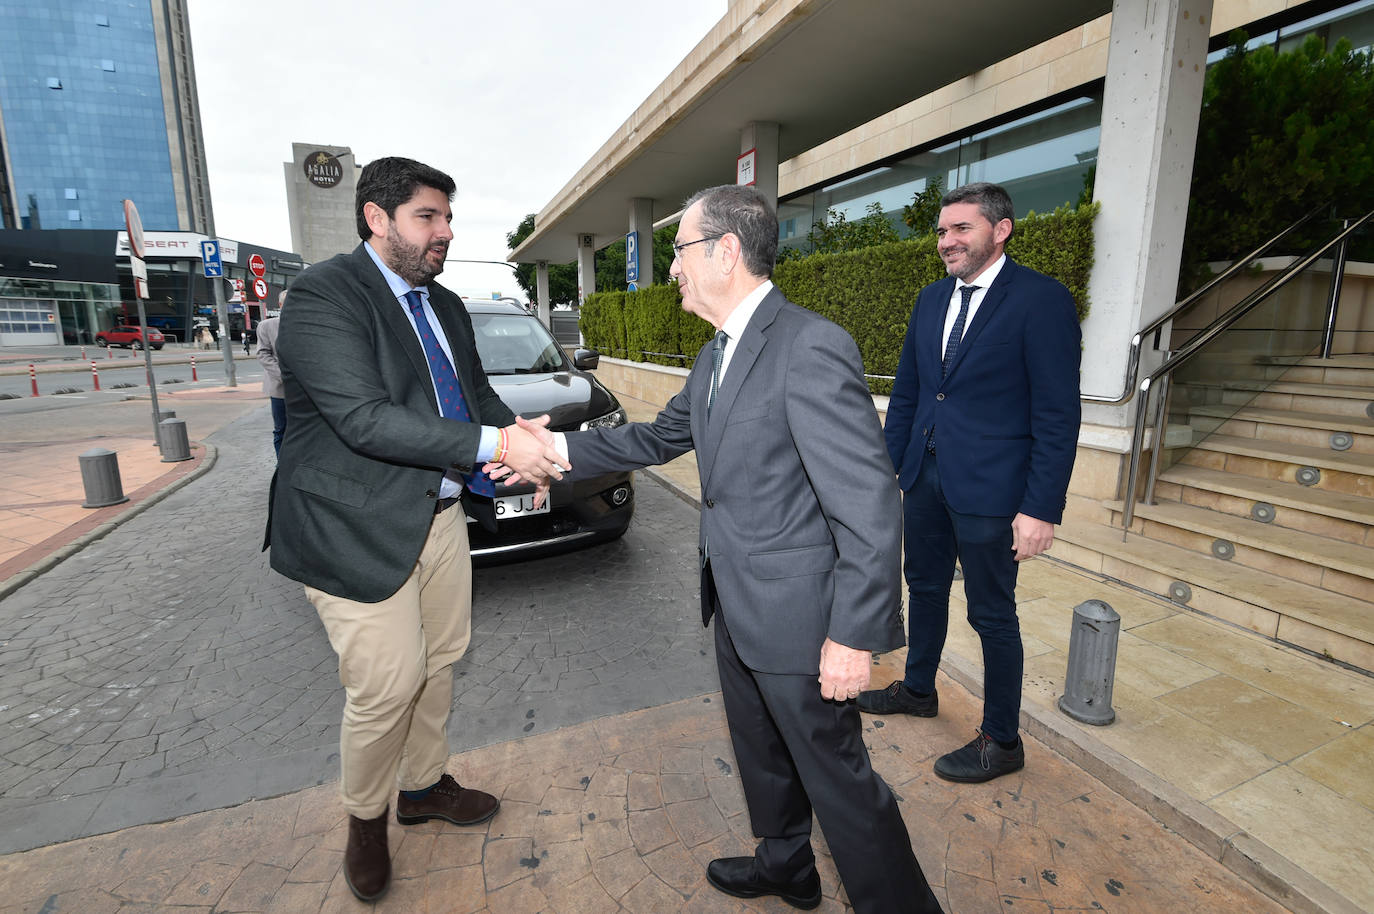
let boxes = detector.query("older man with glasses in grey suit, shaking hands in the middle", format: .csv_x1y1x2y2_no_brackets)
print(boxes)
497,186,940,914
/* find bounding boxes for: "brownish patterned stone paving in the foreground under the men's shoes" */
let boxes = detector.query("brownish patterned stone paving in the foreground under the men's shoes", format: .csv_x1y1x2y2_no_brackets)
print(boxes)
0,654,1285,914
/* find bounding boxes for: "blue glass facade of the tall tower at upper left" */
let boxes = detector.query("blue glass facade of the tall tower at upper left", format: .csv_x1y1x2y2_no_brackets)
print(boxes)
0,0,203,231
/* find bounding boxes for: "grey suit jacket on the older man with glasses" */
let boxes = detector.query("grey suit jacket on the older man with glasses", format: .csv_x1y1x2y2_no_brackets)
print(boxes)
567,289,904,673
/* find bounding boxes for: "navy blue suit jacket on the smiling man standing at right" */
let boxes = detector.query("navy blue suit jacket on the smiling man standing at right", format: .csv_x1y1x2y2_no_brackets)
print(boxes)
883,258,1083,524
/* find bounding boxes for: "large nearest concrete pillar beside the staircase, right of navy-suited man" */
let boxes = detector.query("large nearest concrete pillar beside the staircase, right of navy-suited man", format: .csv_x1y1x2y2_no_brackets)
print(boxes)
1083,0,1212,427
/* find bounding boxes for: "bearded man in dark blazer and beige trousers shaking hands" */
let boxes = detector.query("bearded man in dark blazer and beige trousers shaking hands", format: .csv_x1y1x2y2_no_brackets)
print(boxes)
268,158,561,900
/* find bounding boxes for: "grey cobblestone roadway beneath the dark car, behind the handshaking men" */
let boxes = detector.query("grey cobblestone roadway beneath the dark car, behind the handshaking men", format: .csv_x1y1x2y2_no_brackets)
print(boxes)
0,410,717,852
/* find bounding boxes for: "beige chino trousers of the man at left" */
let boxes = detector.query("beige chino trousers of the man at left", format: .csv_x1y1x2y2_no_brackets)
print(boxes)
305,506,473,819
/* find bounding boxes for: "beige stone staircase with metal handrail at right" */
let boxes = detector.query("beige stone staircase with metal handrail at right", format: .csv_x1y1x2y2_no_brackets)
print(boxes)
1051,356,1374,672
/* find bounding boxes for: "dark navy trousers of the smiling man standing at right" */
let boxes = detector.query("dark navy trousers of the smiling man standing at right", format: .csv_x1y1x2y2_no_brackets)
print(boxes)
903,454,1025,742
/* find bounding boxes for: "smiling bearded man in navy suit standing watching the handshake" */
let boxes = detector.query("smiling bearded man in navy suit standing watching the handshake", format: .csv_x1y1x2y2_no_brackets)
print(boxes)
859,183,1081,782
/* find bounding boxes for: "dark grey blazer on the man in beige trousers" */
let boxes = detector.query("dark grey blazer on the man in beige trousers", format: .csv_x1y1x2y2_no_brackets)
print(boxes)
268,245,514,602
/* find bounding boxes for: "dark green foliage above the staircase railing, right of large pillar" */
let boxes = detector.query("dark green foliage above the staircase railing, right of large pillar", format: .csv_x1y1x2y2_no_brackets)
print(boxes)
1183,32,1374,282
